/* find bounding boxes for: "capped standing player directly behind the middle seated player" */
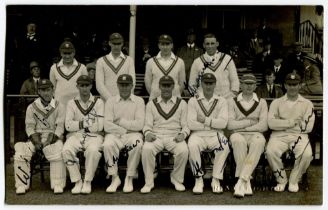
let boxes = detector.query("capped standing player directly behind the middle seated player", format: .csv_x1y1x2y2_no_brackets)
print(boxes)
145,34,186,100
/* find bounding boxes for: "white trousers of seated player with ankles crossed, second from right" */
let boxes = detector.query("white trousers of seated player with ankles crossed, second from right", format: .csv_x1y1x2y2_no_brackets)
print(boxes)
230,133,266,181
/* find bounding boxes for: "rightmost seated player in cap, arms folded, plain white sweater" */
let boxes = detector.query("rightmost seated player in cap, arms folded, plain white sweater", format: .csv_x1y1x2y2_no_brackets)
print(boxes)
266,73,315,192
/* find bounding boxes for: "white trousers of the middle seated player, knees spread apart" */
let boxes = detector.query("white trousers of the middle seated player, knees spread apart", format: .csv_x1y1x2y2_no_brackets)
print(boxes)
141,135,188,185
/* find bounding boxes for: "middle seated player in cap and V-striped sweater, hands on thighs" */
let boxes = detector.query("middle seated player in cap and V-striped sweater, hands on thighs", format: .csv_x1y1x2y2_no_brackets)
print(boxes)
141,75,190,193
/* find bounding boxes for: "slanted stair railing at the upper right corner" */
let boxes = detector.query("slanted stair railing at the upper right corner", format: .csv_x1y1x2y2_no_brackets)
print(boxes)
298,20,323,54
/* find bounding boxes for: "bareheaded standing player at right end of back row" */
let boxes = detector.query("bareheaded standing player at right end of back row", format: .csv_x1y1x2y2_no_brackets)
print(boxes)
189,33,239,98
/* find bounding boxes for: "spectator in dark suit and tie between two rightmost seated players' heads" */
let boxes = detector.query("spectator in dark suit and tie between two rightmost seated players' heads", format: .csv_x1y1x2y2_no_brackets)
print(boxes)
256,69,283,98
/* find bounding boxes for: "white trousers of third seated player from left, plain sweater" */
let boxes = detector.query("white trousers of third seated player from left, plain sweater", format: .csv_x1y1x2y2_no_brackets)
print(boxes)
103,133,143,177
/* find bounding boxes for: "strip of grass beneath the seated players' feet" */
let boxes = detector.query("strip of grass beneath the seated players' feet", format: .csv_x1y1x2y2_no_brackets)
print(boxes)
5,164,323,205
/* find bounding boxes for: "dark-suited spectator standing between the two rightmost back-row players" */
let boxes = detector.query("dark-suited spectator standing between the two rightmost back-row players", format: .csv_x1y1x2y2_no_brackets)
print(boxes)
177,29,204,82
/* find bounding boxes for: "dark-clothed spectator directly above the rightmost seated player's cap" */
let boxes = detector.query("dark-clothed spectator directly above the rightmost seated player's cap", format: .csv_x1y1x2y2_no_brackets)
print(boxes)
286,42,306,77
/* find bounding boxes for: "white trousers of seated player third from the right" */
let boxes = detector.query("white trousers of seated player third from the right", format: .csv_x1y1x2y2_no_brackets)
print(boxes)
188,133,230,179
